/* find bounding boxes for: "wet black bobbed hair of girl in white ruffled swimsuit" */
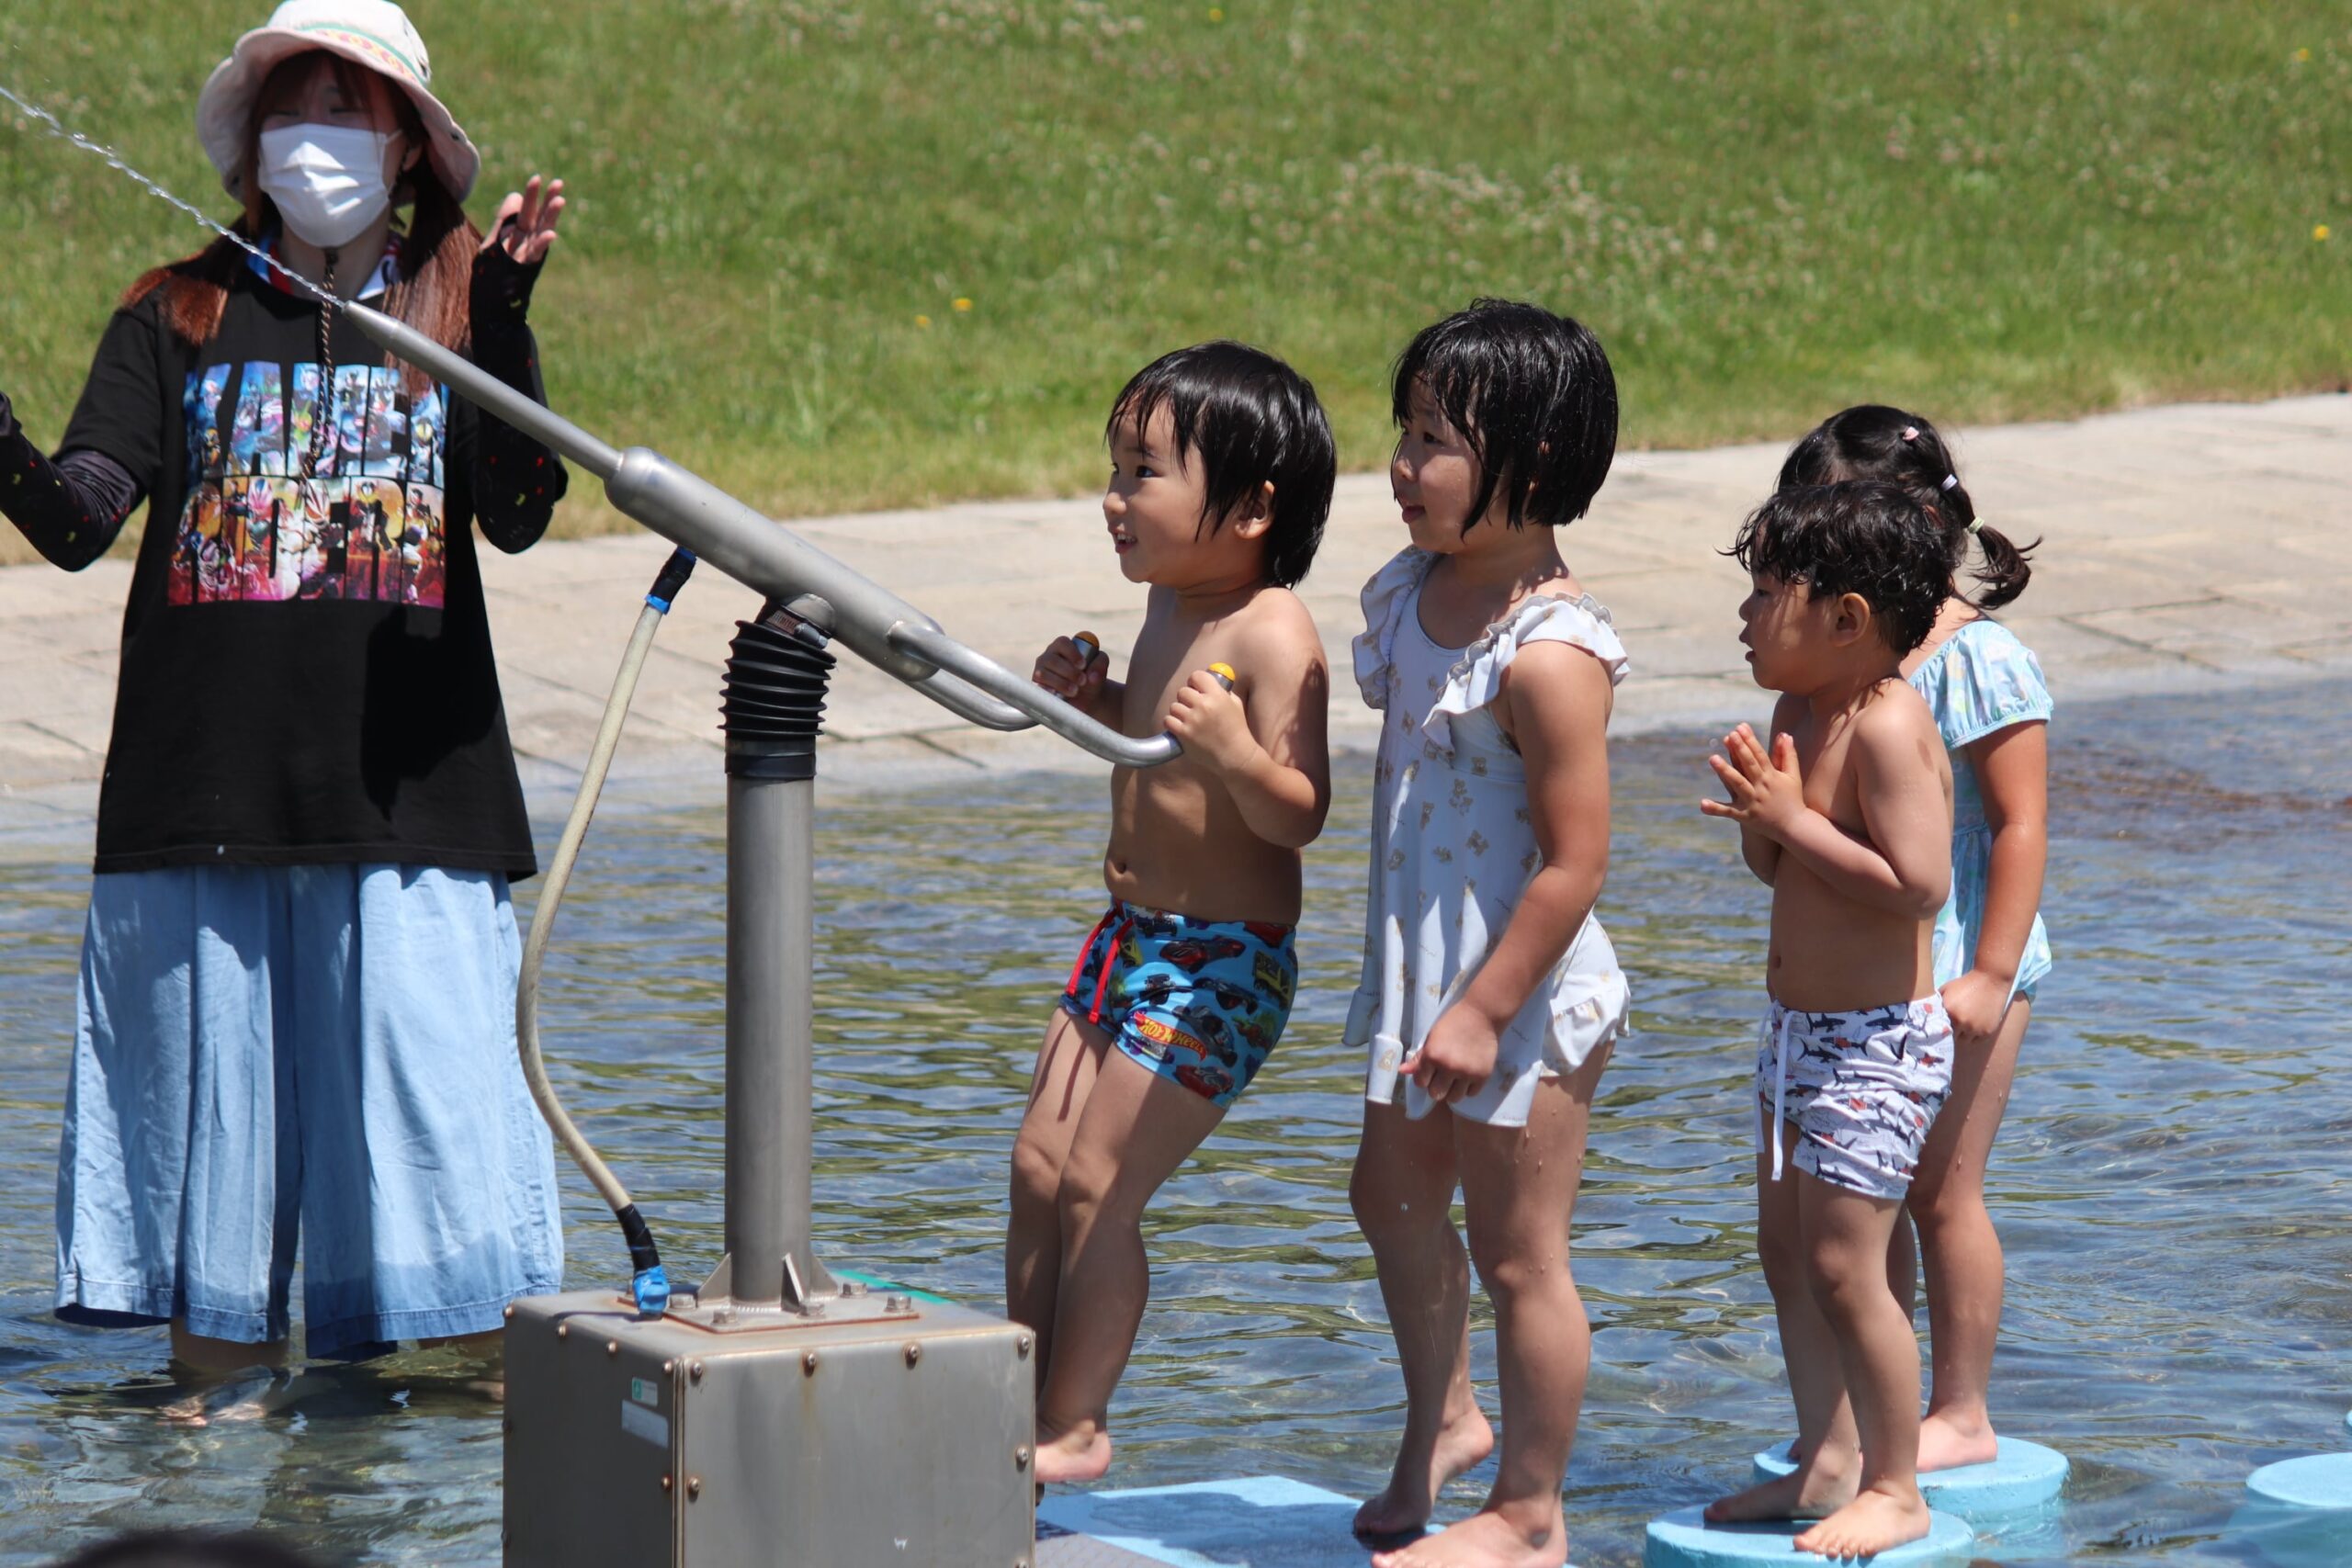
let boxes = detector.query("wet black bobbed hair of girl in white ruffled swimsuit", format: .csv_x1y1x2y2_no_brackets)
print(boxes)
1390,299,1616,534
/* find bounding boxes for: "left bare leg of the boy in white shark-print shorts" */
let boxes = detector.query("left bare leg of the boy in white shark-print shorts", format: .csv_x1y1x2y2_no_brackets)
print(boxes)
1708,1146,1863,1523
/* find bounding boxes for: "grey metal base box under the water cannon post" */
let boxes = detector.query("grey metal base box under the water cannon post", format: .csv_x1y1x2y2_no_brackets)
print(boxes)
505,1291,1037,1568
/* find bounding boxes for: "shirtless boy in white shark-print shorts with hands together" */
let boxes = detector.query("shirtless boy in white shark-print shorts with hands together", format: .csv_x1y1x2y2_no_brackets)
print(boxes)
1701,482,1952,1556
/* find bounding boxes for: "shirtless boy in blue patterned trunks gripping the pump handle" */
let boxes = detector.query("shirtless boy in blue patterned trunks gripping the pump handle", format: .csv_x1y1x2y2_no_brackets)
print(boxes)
1004,344,1336,1483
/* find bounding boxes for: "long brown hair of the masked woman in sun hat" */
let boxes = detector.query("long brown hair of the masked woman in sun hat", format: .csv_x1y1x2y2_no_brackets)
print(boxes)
122,50,482,395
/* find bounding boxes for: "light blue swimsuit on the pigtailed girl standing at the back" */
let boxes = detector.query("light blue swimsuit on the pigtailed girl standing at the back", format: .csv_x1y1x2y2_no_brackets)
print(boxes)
1910,621,2051,1001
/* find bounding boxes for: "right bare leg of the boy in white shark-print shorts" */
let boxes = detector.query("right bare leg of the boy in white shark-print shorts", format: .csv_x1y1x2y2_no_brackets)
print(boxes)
1792,1170,1928,1556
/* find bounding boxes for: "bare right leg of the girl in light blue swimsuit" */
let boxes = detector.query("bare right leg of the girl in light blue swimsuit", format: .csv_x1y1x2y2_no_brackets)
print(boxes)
1910,997,2032,1472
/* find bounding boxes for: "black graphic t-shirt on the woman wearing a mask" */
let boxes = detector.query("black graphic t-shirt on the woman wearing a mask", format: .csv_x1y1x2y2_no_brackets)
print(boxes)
63,252,564,877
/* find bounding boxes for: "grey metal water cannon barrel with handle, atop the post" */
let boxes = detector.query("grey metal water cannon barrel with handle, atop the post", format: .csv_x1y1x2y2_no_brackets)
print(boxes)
344,303,1183,769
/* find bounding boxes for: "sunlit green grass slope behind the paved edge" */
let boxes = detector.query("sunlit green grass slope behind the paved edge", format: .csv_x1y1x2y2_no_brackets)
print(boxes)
0,0,2352,564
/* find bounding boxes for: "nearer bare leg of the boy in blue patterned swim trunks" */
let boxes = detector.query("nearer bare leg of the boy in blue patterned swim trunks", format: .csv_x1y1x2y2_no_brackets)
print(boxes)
1037,1051,1226,1485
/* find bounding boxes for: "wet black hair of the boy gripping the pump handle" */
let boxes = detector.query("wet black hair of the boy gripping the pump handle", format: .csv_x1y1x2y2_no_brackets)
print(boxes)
1103,339,1339,588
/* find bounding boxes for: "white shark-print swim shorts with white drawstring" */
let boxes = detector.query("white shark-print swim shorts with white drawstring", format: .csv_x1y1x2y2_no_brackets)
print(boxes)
1757,995,1952,1199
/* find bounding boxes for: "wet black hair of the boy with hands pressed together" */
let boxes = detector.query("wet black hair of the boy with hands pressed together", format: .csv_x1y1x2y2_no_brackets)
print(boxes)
1724,479,1952,656
